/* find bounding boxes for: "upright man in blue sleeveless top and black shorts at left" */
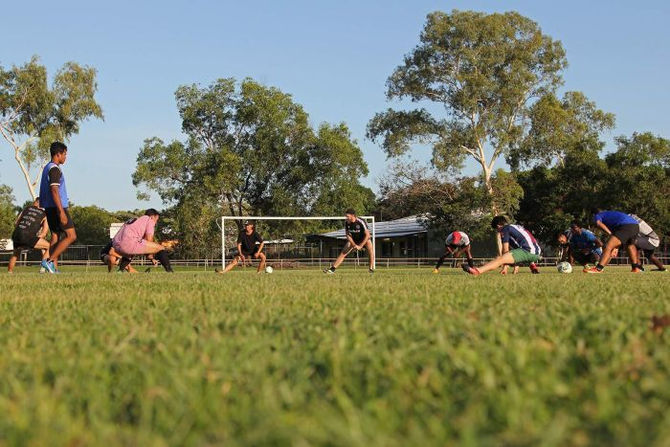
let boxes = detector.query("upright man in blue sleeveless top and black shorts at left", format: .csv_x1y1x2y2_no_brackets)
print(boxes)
40,141,77,273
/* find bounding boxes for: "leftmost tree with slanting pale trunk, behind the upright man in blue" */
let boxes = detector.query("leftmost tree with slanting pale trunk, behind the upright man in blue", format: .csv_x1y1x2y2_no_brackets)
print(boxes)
0,57,103,198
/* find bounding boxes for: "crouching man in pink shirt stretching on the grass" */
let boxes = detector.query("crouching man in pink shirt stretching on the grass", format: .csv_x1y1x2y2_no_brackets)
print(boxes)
112,208,172,272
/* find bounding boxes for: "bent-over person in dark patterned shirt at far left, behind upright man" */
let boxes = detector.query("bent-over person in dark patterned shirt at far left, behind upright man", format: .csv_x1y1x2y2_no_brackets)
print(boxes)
7,197,49,273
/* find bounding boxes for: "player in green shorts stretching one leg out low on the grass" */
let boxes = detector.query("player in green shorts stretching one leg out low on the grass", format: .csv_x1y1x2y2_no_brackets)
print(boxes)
461,216,542,276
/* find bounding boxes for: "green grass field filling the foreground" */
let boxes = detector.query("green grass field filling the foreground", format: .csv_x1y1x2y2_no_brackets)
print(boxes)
0,269,670,446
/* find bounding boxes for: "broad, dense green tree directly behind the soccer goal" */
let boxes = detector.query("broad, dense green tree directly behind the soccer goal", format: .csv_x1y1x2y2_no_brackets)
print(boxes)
133,78,373,258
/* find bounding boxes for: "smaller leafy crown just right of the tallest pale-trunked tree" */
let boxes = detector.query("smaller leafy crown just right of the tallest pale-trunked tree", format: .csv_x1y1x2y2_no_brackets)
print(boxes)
507,92,615,169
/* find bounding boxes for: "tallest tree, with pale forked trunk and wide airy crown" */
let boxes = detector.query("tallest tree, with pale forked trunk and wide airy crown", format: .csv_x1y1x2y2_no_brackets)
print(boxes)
367,11,567,213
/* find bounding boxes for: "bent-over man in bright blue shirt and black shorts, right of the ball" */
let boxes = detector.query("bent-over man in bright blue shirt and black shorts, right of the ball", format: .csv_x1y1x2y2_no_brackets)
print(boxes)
584,209,641,273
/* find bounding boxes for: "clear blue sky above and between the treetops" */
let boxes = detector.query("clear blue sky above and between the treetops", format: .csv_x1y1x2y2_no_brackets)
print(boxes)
0,0,670,210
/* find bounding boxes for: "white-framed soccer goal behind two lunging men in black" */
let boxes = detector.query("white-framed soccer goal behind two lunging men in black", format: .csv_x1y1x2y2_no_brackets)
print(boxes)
221,216,377,268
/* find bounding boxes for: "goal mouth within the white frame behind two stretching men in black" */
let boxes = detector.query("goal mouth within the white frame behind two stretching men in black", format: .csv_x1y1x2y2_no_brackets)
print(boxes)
220,216,377,269
